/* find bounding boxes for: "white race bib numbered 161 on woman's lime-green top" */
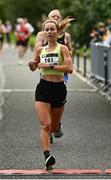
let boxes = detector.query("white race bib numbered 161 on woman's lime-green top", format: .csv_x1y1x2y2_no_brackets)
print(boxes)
41,53,58,65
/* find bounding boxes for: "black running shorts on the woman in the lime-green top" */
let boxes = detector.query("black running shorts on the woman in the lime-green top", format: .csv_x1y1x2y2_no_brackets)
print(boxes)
35,79,67,108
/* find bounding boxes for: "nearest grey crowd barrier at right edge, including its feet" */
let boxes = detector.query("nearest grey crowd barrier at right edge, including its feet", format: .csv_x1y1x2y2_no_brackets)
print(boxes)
90,43,111,101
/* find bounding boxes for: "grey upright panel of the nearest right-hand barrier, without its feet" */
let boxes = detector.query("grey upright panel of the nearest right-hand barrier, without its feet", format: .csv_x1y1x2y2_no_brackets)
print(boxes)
91,43,111,85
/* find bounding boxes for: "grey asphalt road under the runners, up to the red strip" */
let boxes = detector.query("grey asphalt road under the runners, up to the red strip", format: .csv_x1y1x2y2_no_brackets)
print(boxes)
0,48,111,179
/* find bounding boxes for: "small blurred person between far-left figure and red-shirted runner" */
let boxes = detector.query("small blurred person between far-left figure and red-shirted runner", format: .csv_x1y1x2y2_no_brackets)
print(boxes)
5,20,12,44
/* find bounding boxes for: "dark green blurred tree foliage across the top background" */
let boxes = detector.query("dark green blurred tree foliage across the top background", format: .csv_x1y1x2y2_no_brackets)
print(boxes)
0,0,111,46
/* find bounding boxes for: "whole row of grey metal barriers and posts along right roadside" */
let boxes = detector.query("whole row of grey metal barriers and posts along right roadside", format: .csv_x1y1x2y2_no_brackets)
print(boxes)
74,43,111,102
